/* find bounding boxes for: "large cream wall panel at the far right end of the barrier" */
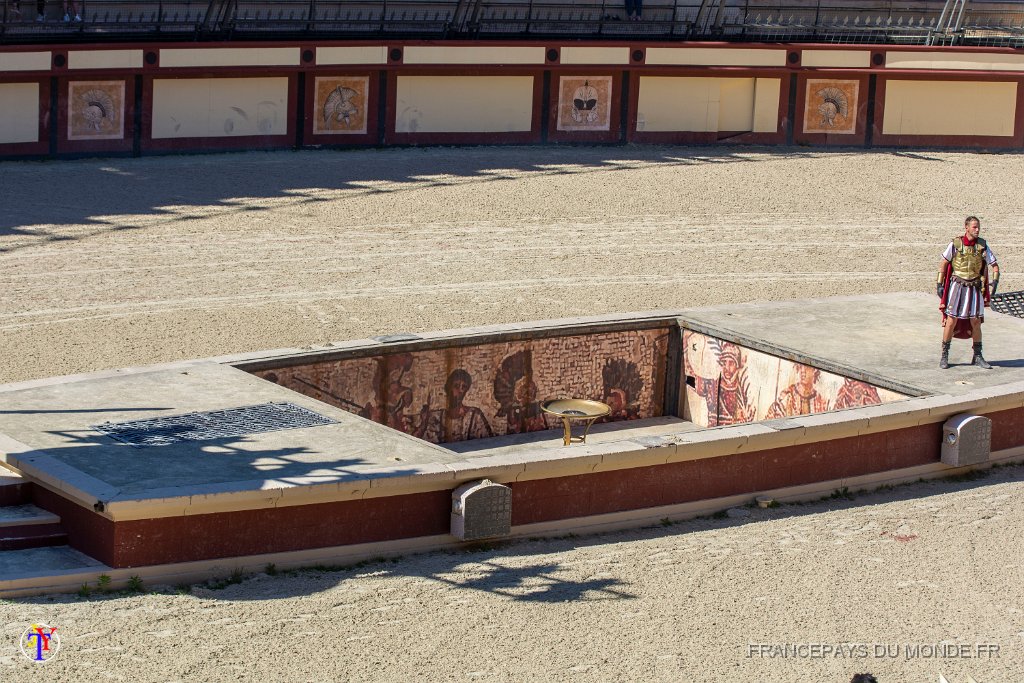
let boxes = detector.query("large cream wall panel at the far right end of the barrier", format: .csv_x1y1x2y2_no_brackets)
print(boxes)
882,80,1017,136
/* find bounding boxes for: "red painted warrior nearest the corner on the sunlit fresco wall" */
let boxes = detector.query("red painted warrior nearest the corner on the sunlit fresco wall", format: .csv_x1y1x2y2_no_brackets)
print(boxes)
685,339,757,427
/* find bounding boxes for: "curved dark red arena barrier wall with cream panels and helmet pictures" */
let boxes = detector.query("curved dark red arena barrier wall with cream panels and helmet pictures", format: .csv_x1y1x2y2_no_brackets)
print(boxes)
0,41,1024,159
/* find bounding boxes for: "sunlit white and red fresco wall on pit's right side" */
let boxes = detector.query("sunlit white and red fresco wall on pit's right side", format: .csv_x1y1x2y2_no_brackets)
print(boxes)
683,330,906,427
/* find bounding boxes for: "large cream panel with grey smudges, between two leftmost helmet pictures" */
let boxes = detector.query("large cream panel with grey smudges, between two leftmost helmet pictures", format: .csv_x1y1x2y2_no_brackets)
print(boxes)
153,78,288,138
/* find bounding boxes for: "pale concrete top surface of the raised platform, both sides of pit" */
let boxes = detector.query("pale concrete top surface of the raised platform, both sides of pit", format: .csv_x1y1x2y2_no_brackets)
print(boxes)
0,293,1024,516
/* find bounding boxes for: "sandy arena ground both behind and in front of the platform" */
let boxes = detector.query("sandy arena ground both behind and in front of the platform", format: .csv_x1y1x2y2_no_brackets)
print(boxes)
0,146,1024,683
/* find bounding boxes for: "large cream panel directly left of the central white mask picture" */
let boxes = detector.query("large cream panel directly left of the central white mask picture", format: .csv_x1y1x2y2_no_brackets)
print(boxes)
395,76,534,133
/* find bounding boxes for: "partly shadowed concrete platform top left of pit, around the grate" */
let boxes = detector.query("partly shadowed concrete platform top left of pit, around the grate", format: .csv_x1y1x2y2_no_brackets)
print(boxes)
0,362,461,501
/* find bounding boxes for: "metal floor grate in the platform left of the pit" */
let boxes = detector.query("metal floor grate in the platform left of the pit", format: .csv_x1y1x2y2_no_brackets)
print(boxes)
92,402,337,446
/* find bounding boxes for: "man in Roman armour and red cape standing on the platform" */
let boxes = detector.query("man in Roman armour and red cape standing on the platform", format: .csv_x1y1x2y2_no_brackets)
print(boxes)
935,216,999,370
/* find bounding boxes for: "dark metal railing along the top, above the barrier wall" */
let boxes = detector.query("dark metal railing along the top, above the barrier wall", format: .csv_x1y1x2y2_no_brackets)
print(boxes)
6,0,1024,47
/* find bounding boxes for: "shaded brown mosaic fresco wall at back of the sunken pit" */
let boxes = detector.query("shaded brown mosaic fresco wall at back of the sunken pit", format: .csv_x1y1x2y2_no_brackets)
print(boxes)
254,329,669,443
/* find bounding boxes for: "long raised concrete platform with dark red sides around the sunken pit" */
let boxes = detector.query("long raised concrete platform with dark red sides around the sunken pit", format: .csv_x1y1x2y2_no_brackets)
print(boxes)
0,293,1024,590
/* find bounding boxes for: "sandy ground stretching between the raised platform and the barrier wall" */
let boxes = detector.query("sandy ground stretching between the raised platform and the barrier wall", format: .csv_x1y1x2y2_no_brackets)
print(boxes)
0,146,1024,382
